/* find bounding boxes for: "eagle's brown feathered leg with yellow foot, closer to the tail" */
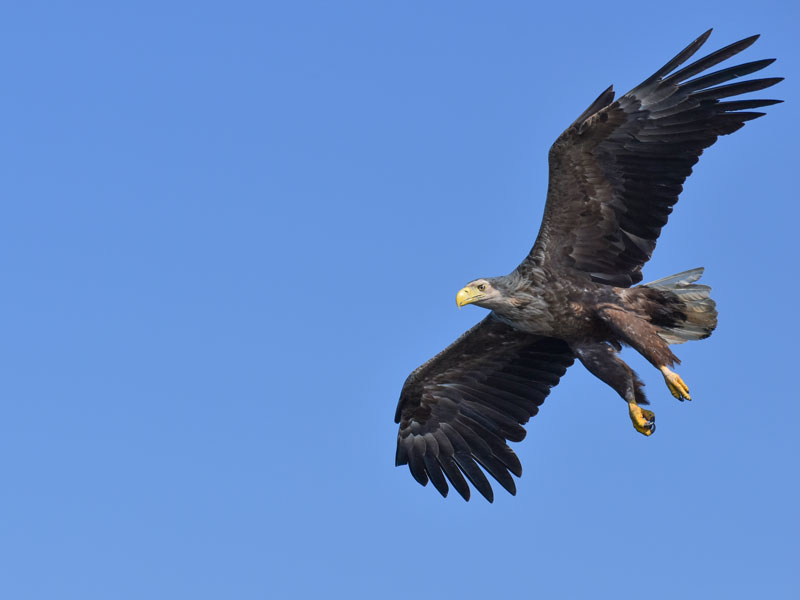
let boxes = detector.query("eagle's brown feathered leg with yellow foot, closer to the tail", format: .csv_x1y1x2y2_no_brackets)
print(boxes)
597,306,692,402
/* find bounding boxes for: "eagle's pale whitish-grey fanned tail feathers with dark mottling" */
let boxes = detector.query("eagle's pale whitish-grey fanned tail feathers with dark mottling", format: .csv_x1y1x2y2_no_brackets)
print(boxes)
641,267,717,344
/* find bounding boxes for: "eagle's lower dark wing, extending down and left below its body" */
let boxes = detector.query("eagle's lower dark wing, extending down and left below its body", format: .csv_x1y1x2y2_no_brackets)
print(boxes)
395,314,573,502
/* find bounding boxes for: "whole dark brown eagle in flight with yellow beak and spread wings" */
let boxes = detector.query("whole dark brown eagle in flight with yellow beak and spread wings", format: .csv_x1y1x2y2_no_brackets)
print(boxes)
395,30,783,502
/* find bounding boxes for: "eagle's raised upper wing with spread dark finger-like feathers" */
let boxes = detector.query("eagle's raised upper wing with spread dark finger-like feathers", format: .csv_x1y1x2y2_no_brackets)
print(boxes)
518,30,782,286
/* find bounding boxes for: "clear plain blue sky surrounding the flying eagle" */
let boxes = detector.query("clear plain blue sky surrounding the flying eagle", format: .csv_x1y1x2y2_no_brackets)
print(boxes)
0,0,800,600
